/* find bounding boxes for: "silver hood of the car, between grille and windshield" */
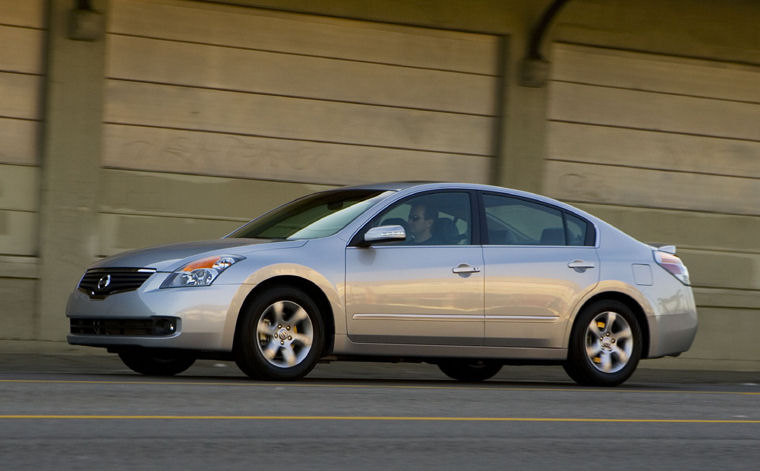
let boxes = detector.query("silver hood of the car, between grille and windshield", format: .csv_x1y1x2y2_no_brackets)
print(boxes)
92,239,306,272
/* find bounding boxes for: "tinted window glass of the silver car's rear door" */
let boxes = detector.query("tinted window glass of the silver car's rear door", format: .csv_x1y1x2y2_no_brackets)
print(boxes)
483,194,593,246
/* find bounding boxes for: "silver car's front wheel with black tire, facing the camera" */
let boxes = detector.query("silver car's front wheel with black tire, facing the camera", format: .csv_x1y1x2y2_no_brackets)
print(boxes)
235,286,325,381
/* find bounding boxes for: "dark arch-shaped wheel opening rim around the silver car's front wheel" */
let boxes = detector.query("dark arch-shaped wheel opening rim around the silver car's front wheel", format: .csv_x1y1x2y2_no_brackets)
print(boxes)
233,275,335,356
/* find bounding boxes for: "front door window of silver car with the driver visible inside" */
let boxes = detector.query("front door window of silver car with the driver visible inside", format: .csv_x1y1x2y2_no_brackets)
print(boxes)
370,192,472,245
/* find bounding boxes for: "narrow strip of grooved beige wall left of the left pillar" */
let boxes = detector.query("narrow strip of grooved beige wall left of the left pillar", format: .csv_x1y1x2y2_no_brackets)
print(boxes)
0,0,47,338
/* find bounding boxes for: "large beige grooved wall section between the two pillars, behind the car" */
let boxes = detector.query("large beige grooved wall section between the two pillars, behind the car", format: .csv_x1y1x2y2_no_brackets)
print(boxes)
98,0,499,255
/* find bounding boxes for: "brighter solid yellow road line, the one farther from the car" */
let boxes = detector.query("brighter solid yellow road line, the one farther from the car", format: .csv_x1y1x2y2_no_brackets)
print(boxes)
0,414,760,424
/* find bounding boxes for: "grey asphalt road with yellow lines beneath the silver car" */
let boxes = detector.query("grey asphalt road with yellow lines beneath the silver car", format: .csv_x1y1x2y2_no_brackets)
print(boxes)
0,352,760,470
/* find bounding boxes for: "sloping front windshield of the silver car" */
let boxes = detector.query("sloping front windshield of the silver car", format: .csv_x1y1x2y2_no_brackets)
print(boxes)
227,190,392,240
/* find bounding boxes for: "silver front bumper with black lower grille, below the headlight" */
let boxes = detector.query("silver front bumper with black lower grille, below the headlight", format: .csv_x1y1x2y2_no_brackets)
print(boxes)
66,273,244,351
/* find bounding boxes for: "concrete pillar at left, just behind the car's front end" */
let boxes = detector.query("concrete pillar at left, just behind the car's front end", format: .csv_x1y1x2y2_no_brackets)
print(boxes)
35,0,108,340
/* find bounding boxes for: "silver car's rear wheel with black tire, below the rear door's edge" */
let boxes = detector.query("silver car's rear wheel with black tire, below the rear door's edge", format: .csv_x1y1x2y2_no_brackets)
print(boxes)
563,300,643,386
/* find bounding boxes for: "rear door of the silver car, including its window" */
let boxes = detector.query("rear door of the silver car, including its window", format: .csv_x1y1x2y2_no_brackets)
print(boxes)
481,193,599,348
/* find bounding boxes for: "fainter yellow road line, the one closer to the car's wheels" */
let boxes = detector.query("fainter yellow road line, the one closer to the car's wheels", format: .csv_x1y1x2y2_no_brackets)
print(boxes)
0,379,760,396
